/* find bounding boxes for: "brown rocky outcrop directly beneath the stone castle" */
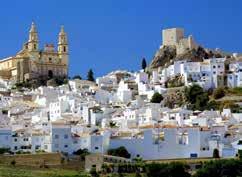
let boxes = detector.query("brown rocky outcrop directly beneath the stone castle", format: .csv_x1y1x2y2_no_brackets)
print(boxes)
149,46,223,70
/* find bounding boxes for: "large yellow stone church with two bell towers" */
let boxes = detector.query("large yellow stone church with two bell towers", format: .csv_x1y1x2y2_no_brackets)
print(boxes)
0,23,69,83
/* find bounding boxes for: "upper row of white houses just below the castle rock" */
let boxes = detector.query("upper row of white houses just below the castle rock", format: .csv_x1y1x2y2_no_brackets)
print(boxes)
152,58,242,90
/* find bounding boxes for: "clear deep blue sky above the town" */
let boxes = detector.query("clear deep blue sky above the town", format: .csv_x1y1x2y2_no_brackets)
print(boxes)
0,0,242,78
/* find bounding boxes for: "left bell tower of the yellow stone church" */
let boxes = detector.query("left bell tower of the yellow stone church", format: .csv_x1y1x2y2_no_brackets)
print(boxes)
27,22,39,52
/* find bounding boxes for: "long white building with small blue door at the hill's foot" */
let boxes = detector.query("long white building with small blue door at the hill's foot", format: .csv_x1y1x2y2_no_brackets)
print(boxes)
110,128,219,160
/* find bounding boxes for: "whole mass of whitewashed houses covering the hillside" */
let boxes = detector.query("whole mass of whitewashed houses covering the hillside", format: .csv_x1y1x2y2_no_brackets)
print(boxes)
0,27,242,160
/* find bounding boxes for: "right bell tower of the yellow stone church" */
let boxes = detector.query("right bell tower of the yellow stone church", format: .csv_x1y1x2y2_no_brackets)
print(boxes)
58,26,69,66
